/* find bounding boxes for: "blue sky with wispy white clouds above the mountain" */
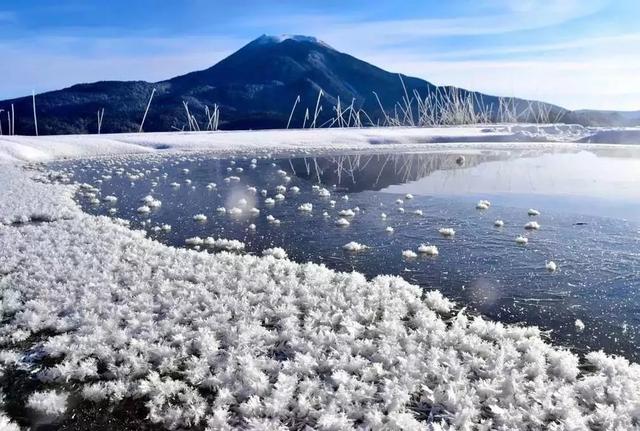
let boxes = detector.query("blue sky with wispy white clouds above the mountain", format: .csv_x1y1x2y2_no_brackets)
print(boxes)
0,0,640,110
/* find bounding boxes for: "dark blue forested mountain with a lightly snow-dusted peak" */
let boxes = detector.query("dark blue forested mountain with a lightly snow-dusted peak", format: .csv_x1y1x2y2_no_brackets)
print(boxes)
0,35,637,134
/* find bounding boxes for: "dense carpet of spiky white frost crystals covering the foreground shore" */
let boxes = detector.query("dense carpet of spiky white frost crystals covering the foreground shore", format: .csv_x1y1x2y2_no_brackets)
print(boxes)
0,127,640,429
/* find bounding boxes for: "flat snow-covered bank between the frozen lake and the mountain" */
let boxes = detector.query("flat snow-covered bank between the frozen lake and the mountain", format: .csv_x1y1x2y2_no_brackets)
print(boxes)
0,125,615,162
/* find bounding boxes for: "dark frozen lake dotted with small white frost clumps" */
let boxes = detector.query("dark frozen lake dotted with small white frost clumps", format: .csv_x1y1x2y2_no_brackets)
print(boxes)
58,148,640,361
